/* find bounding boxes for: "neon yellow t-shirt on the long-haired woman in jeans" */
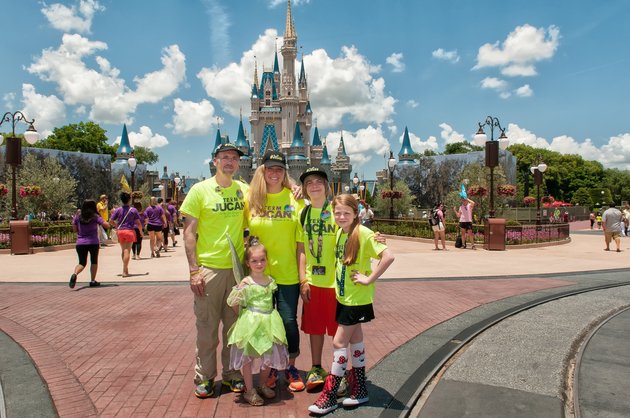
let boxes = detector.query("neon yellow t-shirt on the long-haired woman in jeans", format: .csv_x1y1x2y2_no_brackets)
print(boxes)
248,188,304,285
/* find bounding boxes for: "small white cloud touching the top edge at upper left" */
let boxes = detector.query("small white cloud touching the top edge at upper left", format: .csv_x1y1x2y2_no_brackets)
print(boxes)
41,0,105,33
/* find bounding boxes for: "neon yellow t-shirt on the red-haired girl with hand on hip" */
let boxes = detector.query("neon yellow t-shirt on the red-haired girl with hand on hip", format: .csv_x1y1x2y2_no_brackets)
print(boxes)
335,225,387,306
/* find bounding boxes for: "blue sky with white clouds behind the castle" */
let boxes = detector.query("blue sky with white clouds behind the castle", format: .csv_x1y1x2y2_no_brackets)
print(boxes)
0,0,630,179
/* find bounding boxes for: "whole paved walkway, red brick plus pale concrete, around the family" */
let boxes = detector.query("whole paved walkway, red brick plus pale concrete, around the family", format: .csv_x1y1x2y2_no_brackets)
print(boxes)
0,220,630,417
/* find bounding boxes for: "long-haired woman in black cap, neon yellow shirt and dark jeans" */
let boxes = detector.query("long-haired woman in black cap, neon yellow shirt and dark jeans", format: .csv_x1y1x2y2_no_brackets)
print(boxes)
247,151,304,392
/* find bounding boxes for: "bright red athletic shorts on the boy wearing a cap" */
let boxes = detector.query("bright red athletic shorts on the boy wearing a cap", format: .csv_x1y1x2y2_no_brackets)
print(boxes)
301,285,337,337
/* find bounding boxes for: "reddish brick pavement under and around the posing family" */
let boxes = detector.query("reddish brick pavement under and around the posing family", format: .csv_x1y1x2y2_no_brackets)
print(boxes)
0,278,570,417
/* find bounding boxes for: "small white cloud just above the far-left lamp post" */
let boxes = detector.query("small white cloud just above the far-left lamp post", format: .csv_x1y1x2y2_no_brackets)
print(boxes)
22,84,66,139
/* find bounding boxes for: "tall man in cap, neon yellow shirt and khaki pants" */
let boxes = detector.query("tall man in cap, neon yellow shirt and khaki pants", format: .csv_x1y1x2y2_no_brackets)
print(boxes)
180,144,247,398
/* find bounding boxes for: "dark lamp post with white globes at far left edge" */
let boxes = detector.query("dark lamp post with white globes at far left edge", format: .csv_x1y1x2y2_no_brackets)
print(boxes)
0,110,39,219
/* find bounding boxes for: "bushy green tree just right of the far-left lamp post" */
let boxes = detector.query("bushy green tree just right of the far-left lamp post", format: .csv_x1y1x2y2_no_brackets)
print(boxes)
7,153,77,218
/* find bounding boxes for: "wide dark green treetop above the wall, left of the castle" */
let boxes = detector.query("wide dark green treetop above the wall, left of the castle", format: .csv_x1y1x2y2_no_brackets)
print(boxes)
34,122,116,161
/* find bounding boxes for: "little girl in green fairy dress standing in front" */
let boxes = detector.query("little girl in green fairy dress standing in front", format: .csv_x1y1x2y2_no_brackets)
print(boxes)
227,237,289,406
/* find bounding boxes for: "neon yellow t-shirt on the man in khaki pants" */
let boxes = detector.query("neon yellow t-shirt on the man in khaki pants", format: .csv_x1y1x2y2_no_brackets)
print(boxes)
180,177,249,269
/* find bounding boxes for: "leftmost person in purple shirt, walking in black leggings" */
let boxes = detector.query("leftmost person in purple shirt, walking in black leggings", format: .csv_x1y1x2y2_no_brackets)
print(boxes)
68,200,109,289
